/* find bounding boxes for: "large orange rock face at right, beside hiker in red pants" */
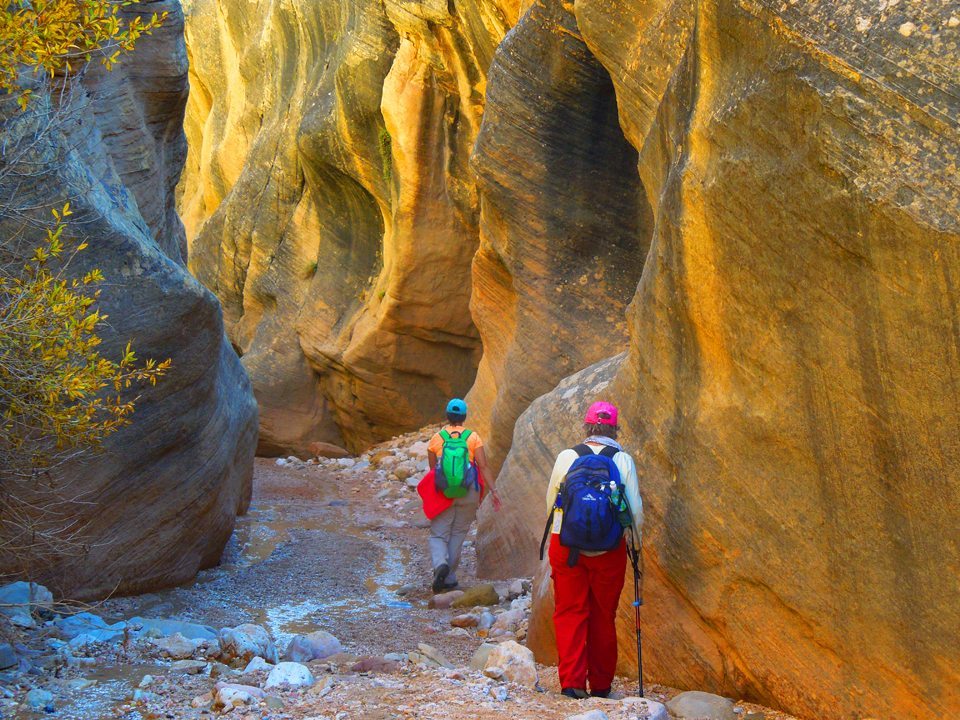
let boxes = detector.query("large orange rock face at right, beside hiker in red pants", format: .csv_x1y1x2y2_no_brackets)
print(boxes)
478,0,960,719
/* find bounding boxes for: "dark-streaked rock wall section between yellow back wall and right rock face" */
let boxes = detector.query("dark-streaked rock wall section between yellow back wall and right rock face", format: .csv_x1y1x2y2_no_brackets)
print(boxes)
468,0,652,472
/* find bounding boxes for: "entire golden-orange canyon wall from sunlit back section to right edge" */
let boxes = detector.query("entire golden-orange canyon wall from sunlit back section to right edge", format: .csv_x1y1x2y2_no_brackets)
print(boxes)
180,0,960,719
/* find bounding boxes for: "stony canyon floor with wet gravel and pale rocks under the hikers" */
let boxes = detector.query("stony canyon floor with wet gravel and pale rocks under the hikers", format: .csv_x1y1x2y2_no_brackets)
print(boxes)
0,434,804,720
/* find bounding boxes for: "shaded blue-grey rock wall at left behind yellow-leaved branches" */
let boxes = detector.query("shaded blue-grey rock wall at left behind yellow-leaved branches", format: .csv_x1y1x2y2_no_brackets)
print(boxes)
0,0,257,598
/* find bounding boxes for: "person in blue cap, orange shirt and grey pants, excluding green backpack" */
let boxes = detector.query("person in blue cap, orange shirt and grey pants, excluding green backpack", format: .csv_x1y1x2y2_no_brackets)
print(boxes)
427,398,500,592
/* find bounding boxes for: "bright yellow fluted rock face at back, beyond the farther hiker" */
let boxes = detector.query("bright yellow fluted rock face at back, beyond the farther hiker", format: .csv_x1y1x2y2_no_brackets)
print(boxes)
181,0,517,454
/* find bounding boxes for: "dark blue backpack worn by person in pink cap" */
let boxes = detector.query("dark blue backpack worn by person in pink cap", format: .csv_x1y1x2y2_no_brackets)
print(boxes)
540,445,629,567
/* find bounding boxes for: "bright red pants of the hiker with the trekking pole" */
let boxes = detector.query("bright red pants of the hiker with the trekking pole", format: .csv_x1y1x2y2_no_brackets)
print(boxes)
550,535,627,692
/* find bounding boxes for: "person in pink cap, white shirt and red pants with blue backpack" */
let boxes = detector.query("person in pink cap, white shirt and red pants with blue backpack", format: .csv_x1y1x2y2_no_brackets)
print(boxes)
544,402,643,699
